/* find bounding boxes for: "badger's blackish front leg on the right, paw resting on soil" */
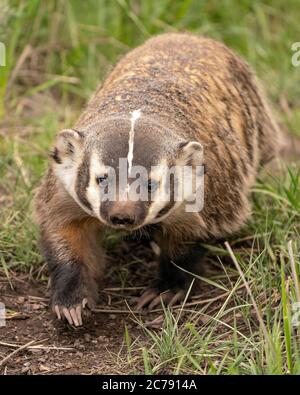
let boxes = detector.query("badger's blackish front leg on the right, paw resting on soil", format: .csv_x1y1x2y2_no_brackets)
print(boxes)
137,244,206,310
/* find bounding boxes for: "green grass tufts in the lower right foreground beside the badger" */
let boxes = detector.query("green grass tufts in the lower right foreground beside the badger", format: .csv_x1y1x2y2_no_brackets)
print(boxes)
120,170,300,374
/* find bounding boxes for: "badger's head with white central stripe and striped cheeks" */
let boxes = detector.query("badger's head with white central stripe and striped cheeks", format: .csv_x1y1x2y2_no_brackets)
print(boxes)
51,111,203,231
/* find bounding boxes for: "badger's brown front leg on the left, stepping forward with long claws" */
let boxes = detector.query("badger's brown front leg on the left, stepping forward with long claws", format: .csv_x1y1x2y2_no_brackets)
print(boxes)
41,220,104,326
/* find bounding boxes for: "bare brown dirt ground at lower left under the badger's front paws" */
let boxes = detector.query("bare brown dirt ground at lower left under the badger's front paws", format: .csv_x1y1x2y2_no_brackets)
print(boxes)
0,243,155,374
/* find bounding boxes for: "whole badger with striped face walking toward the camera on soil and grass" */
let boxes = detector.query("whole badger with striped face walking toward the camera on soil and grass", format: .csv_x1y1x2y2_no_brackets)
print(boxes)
34,33,282,326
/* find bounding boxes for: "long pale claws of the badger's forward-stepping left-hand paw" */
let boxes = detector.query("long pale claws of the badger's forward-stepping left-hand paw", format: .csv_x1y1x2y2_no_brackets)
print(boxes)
52,298,94,326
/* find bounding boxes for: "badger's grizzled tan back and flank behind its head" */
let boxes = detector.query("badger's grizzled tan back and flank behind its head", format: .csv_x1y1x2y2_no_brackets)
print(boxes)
76,33,279,236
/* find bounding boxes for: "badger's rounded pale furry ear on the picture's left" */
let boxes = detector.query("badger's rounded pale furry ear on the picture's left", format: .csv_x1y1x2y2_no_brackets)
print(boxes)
50,129,84,164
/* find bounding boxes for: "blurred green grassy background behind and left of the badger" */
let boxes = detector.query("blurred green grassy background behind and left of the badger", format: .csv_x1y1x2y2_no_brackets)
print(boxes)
0,0,300,276
